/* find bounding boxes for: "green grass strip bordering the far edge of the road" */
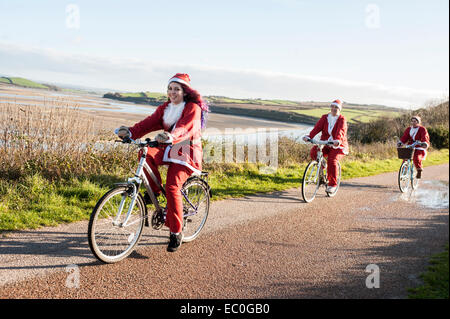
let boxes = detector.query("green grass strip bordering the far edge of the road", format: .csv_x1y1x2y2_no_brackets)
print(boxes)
0,150,449,231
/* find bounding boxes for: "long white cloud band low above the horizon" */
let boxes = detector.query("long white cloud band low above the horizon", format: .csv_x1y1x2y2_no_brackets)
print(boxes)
0,43,448,107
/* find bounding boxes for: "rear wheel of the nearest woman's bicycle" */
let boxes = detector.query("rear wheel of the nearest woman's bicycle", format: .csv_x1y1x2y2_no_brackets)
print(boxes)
181,177,210,242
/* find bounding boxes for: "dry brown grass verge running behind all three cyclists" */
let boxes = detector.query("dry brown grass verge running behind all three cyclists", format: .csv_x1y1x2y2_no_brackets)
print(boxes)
0,100,448,180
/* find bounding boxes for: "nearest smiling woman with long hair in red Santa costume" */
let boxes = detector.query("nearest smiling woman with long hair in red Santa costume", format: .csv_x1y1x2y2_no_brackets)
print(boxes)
117,73,207,252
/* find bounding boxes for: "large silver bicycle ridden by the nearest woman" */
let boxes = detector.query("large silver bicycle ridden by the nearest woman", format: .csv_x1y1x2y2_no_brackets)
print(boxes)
88,138,211,263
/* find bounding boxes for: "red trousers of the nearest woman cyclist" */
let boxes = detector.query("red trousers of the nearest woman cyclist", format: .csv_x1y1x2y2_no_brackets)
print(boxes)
140,147,192,233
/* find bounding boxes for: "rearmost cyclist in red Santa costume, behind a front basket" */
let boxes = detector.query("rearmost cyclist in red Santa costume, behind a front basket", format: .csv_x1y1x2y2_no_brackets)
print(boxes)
397,115,430,178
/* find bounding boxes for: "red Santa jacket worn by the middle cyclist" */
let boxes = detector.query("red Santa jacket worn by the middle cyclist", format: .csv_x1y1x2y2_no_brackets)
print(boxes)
309,114,348,155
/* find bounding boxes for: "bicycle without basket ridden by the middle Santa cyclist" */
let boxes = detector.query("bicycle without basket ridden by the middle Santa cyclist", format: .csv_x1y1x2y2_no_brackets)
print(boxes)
302,139,341,203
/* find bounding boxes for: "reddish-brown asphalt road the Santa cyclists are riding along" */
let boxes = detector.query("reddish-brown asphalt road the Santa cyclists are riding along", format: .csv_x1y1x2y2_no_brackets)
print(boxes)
0,164,449,299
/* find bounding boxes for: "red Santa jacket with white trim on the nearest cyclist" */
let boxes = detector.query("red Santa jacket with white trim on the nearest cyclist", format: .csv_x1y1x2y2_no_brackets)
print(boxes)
130,102,203,173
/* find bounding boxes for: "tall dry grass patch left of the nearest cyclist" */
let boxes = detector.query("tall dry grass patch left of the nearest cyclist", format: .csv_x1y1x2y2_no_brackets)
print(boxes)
0,103,133,180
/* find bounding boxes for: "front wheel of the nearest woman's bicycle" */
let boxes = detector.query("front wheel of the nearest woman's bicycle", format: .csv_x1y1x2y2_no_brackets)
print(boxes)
88,186,146,263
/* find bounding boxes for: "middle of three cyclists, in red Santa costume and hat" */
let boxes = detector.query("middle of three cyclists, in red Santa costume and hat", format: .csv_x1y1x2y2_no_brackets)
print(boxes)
303,100,348,193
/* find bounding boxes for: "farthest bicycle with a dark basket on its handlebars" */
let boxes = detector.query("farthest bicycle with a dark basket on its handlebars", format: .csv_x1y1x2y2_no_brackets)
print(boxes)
397,142,421,193
